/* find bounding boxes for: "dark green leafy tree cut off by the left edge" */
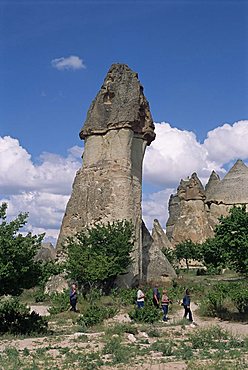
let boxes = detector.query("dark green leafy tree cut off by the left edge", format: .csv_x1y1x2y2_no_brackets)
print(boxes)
0,203,44,295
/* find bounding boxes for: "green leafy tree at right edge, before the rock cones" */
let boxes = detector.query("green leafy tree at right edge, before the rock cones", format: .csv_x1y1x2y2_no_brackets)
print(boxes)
201,205,248,274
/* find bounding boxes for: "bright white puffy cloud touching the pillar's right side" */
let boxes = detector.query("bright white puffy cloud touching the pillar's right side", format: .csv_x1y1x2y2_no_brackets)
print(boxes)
144,122,223,187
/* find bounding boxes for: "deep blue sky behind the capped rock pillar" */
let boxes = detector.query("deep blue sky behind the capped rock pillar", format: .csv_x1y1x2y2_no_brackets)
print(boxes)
0,0,248,241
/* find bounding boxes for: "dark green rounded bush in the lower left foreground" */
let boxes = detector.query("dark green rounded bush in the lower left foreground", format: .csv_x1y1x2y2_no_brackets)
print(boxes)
0,298,47,334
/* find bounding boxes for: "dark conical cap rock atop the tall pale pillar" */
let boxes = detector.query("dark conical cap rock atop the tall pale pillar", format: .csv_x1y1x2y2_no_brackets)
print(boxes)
80,64,155,145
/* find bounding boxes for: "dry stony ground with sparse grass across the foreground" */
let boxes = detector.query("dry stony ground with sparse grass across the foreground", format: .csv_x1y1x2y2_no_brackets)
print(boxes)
0,303,248,370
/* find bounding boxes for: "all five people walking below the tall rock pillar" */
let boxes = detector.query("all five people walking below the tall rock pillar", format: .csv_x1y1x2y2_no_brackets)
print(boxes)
70,284,193,322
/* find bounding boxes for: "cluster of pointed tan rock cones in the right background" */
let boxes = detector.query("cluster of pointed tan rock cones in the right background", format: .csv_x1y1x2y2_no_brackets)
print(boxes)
166,160,248,245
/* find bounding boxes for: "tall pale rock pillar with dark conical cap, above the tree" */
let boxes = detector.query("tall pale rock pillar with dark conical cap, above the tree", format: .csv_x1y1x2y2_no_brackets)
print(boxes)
56,64,155,286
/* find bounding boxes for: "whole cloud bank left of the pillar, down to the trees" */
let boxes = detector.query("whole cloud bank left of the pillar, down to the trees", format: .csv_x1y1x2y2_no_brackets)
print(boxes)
0,136,83,243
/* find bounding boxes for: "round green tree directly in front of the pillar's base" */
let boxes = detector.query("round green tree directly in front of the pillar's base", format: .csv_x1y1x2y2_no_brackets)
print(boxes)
64,221,134,287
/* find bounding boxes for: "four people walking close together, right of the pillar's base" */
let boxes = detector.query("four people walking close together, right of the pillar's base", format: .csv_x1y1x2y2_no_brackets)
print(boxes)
137,286,193,322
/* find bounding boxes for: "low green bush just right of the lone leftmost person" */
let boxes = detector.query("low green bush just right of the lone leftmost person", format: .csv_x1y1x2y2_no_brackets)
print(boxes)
78,304,117,327
